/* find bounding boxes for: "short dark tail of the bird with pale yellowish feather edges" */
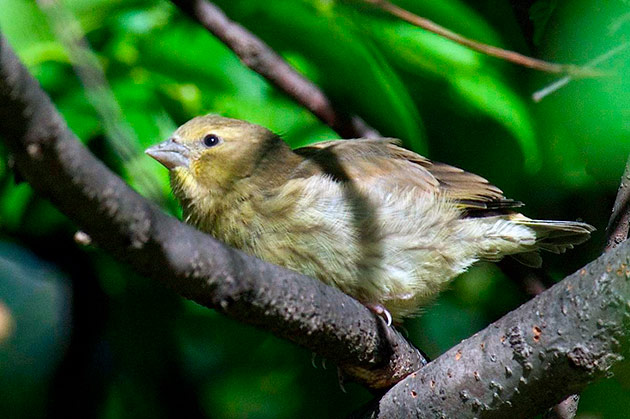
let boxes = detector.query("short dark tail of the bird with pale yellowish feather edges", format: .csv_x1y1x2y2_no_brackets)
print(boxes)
509,214,595,267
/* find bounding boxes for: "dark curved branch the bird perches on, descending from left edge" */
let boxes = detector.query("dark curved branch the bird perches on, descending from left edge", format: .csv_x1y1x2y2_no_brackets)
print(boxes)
0,34,424,388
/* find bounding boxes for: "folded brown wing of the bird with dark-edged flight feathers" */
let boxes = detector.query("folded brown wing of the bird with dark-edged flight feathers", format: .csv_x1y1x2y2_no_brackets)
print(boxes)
294,138,523,211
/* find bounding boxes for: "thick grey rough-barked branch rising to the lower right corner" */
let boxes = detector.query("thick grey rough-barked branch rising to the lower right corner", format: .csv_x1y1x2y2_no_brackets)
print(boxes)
356,242,630,418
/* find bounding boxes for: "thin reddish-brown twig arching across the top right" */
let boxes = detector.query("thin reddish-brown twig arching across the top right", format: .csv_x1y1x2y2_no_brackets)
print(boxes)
362,0,599,77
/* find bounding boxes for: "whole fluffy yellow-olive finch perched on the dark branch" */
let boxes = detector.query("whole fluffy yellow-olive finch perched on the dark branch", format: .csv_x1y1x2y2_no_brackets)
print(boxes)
146,114,594,324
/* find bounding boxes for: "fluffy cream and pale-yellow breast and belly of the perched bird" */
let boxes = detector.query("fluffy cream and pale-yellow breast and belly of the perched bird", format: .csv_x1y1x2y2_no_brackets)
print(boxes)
185,176,473,318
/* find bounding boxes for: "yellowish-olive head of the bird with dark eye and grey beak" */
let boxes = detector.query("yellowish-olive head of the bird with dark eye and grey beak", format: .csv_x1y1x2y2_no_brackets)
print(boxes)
145,115,286,199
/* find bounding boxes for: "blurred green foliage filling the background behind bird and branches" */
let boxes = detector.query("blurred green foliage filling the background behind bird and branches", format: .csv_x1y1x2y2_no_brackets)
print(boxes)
0,0,630,418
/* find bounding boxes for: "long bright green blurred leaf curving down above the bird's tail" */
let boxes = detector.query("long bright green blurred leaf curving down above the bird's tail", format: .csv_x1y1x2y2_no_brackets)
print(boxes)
354,16,541,172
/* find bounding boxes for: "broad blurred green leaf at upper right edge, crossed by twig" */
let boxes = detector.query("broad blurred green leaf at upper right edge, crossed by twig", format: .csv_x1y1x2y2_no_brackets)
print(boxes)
536,0,630,191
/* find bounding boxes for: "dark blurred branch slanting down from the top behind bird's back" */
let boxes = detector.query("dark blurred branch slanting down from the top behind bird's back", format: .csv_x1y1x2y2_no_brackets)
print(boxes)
172,0,380,138
